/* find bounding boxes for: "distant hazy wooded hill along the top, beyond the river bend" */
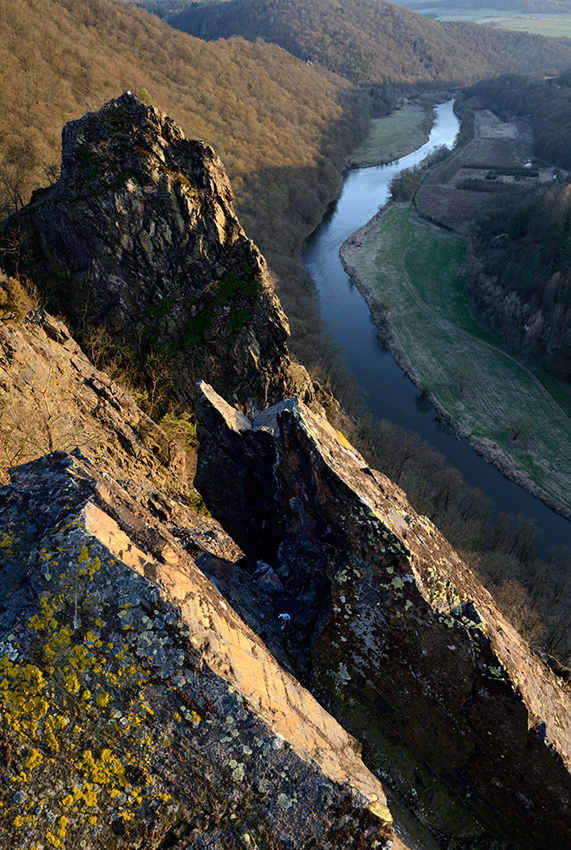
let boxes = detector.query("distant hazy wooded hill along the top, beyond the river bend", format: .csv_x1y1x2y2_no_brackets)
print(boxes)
167,0,571,84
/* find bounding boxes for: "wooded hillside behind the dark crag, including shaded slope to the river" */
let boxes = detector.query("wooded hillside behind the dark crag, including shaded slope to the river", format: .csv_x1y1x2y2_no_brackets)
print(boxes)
0,0,376,374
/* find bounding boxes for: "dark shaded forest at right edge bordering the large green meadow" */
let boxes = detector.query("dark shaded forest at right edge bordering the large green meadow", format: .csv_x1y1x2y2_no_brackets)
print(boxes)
468,185,571,380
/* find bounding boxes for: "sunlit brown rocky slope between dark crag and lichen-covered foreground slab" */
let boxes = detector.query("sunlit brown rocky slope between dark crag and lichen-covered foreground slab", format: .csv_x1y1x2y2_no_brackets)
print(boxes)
0,310,249,560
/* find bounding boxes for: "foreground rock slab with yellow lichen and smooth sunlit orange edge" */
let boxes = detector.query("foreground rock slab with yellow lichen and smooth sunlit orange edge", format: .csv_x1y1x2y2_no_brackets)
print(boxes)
0,452,394,850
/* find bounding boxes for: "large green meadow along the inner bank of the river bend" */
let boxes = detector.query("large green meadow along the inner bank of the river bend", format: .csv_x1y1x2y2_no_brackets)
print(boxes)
351,206,571,509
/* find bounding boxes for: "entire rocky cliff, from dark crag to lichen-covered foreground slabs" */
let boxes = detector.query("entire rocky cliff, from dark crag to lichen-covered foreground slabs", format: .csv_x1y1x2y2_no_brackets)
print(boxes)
0,95,571,850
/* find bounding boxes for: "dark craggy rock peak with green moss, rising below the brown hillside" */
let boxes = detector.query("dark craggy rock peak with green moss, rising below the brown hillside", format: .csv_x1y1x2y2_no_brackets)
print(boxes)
2,93,311,411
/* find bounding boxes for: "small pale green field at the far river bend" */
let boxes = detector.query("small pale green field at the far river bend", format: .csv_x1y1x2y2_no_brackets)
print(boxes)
347,106,426,168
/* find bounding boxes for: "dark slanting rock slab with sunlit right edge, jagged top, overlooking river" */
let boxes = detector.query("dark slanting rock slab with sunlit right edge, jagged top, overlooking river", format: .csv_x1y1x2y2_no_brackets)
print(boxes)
196,385,571,850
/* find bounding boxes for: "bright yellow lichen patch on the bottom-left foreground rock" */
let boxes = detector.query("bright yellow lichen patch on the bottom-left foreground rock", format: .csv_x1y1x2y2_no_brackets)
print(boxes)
0,540,184,850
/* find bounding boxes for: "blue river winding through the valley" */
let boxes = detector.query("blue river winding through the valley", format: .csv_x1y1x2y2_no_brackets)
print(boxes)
305,101,571,546
